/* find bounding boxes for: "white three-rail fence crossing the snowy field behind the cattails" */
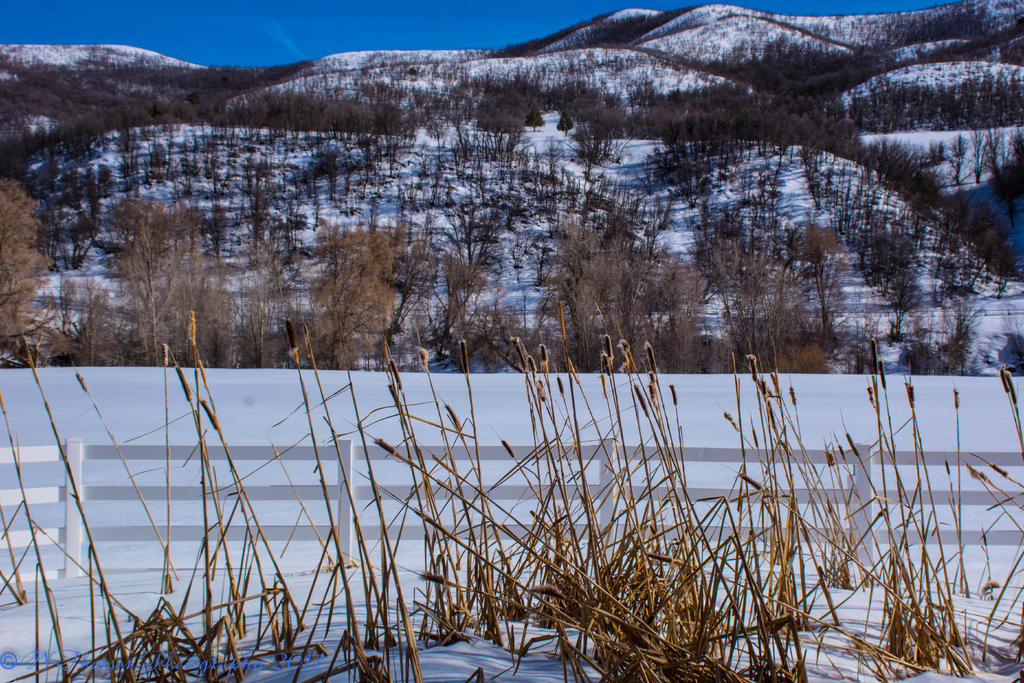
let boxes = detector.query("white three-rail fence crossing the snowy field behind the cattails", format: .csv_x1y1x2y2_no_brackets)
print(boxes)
0,438,1024,577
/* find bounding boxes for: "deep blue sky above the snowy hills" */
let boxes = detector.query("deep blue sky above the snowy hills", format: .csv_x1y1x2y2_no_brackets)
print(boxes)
0,0,950,66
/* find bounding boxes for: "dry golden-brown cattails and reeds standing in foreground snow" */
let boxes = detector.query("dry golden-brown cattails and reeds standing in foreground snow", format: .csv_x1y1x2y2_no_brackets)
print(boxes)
4,325,1024,683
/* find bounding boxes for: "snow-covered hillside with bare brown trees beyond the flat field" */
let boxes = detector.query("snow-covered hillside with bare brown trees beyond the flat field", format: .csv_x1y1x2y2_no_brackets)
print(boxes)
0,0,1024,374
